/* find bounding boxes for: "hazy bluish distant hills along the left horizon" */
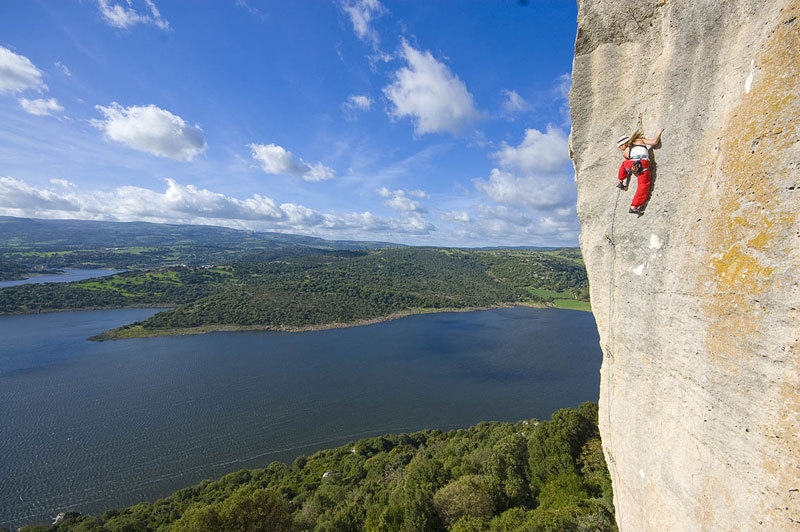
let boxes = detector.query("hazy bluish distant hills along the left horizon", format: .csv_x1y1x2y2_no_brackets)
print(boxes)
0,216,398,280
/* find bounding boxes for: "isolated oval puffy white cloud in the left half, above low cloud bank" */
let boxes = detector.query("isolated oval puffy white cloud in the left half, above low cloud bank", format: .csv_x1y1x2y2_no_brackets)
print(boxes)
91,102,208,161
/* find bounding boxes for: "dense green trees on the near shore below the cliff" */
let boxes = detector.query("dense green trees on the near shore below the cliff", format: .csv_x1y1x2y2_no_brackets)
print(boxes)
10,403,616,532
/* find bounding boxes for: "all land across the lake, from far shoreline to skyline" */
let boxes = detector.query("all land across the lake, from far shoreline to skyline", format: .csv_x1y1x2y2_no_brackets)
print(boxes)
0,218,589,340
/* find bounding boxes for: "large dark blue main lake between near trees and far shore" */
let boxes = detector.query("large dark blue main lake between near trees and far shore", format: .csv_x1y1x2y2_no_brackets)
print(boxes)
0,307,602,528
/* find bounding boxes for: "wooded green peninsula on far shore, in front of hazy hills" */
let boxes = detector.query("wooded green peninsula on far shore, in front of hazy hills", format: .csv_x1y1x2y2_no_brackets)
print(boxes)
0,247,589,339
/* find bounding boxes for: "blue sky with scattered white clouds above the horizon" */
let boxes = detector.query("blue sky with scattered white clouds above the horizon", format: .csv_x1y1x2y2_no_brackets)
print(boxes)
0,0,579,247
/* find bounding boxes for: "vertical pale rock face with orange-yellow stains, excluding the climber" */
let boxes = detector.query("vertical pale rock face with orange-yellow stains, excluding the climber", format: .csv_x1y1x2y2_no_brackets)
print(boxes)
570,0,800,532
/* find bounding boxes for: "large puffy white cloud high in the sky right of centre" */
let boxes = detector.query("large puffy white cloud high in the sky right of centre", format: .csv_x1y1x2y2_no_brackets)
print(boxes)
383,41,481,134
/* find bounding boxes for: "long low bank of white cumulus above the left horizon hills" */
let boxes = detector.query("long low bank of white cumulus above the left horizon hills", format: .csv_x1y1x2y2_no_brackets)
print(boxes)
0,177,432,238
